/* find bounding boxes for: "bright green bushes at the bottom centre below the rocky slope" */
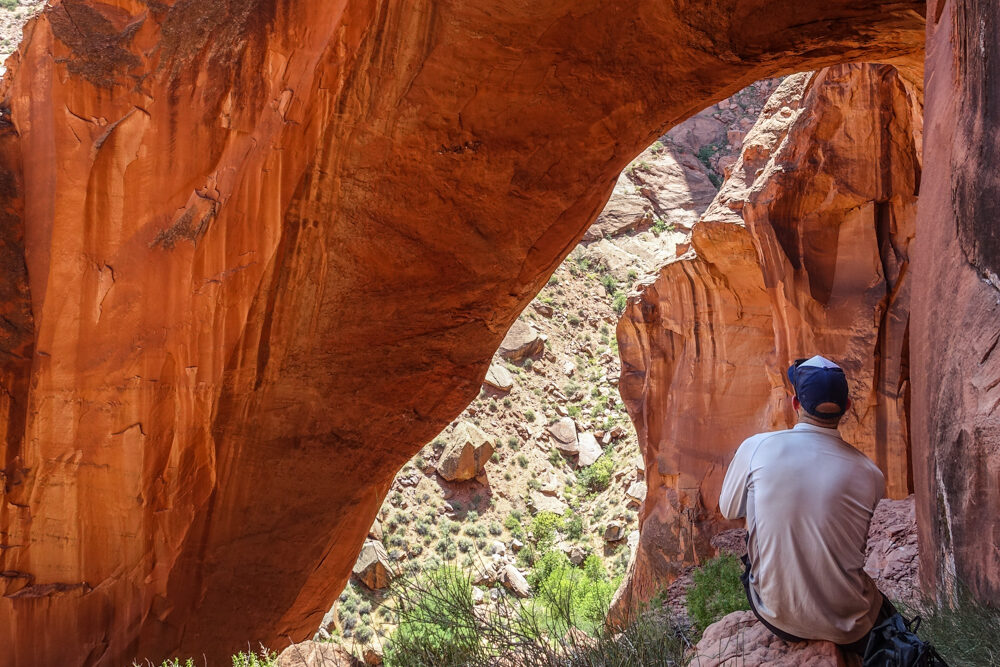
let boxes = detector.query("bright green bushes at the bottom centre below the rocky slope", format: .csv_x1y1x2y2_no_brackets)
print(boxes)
385,563,686,667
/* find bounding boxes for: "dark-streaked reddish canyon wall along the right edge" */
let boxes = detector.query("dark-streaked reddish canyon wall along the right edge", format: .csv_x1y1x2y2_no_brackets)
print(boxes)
911,0,1000,602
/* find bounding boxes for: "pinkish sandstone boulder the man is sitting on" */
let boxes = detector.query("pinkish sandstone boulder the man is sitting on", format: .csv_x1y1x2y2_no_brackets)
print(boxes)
690,611,849,667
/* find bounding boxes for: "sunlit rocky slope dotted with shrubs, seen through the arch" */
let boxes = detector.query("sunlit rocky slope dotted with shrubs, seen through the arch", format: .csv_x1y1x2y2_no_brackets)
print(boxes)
317,80,778,657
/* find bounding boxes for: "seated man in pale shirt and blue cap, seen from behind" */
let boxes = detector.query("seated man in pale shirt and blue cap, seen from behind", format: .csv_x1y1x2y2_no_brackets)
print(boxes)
719,356,894,653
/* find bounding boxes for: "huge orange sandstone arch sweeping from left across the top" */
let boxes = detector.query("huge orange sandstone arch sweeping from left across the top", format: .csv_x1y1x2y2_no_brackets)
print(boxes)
0,0,924,667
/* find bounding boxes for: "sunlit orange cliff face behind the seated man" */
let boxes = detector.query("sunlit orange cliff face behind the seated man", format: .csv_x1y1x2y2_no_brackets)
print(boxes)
618,65,921,612
